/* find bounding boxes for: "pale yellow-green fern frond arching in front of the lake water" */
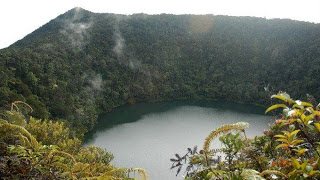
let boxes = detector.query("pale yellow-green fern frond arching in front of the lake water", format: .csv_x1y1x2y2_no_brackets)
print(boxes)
203,122,249,152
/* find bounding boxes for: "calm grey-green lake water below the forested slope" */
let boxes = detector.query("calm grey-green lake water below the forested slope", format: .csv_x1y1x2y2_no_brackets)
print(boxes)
85,100,271,180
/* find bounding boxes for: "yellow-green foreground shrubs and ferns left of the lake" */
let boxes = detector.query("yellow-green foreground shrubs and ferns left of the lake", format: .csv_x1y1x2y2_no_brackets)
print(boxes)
0,101,148,180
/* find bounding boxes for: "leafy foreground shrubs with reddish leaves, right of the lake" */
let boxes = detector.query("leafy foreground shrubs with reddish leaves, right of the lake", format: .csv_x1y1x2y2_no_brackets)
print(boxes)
171,93,320,180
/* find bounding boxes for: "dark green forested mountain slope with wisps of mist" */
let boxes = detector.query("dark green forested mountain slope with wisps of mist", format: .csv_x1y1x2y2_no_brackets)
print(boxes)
0,8,320,129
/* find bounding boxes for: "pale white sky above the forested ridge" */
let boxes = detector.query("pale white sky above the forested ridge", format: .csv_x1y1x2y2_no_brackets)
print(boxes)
0,0,320,49
